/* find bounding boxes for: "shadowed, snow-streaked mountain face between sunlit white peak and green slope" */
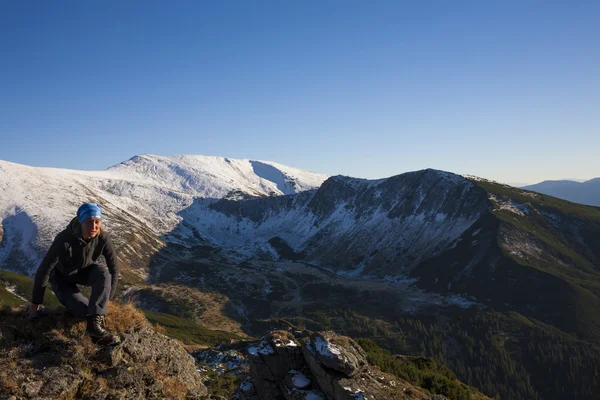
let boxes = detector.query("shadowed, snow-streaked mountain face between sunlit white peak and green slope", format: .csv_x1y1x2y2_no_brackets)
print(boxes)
170,170,489,276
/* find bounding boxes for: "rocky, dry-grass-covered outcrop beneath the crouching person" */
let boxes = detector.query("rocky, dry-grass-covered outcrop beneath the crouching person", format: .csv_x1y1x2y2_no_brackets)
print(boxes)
0,306,208,400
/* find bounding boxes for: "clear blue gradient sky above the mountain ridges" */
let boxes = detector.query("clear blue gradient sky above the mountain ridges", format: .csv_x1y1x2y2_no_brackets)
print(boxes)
0,0,600,184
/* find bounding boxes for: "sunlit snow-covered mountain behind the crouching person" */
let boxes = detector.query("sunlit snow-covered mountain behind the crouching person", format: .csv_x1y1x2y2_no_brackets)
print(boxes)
0,155,327,272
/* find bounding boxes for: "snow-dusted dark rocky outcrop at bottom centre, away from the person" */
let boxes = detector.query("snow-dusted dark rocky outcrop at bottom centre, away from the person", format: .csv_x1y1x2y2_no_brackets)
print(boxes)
236,331,443,400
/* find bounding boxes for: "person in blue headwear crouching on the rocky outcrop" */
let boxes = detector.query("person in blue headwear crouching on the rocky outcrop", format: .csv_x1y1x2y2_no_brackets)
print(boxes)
29,203,120,344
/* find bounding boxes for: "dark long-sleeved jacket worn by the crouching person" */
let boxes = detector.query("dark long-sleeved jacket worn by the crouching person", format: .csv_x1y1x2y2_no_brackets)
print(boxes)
31,218,119,304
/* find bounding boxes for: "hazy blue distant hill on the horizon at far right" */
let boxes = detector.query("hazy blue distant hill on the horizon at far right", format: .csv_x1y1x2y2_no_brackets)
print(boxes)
523,178,600,206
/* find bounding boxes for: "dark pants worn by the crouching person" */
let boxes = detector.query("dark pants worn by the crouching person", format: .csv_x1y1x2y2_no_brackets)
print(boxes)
52,264,111,318
